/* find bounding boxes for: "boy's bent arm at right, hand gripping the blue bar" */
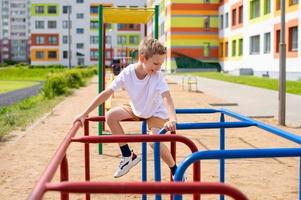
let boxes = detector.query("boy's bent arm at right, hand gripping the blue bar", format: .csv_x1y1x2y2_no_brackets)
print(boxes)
162,91,177,131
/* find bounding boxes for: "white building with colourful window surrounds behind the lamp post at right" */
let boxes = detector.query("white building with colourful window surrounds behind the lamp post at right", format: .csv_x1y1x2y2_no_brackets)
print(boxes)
219,0,301,80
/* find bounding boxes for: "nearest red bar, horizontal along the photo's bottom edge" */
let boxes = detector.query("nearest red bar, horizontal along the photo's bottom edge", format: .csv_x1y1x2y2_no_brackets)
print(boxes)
46,182,248,200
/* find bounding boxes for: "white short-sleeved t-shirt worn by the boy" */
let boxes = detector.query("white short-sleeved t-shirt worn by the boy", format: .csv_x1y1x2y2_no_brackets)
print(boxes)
110,64,169,119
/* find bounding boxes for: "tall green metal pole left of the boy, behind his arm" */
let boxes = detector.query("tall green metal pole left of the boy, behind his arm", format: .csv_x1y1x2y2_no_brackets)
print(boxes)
98,5,104,154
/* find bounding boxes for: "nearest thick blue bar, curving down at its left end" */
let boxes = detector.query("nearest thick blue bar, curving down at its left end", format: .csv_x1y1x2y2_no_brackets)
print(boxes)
174,148,301,200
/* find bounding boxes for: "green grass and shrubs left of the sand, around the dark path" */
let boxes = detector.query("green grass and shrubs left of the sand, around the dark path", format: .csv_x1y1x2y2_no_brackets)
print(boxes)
0,67,96,138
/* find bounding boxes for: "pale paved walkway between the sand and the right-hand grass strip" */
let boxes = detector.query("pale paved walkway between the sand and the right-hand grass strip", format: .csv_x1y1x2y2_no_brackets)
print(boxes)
166,75,301,127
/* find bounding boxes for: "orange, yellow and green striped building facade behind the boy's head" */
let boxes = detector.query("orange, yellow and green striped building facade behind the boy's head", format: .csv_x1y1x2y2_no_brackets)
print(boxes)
148,0,219,72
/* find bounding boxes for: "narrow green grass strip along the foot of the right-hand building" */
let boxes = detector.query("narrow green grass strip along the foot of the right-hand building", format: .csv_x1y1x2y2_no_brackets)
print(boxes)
177,72,301,95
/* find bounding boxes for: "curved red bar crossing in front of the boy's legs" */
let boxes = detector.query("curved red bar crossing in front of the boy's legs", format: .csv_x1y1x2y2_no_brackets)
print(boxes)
72,134,200,184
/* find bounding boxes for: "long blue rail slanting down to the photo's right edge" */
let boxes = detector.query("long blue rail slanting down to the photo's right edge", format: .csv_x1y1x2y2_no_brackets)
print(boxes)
221,109,301,144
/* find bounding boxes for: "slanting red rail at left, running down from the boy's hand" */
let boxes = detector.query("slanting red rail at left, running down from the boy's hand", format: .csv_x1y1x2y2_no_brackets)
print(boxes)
28,122,80,200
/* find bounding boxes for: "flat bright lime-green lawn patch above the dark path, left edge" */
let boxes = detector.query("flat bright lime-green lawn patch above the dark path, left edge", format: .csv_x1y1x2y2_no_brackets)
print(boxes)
0,80,39,94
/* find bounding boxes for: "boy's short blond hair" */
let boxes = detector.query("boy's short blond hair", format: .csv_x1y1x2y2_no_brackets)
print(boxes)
139,38,166,60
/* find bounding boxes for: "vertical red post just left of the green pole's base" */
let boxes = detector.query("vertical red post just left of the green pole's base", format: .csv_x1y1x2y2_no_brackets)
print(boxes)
84,120,91,200
